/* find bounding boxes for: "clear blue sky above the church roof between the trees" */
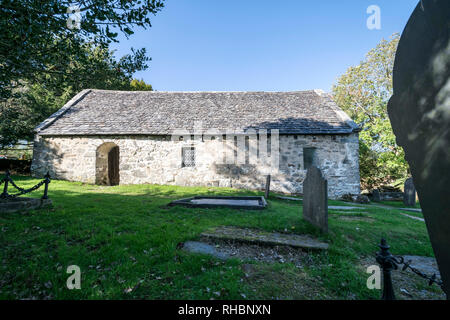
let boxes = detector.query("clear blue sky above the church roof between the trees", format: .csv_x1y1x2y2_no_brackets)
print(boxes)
113,0,418,91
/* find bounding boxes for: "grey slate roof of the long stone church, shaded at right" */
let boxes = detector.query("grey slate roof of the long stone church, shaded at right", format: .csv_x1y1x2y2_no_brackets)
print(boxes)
35,89,359,136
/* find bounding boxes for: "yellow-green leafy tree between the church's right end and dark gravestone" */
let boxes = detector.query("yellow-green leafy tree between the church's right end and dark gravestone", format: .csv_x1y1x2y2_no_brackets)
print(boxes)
333,34,408,188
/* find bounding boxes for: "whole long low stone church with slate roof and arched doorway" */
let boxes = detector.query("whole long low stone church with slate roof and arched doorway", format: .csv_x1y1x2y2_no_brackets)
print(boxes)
31,90,360,198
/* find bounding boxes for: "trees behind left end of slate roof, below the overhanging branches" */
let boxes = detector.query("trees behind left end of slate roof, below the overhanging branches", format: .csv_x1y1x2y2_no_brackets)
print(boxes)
0,44,151,146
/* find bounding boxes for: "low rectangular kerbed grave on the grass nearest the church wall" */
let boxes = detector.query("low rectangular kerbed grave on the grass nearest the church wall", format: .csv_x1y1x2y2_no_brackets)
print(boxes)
169,196,267,210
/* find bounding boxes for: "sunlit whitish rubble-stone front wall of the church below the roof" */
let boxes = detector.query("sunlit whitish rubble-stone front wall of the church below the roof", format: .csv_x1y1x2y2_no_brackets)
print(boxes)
31,133,360,198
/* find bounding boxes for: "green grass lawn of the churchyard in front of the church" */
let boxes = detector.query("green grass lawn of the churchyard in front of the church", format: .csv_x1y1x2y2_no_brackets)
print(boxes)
0,176,433,299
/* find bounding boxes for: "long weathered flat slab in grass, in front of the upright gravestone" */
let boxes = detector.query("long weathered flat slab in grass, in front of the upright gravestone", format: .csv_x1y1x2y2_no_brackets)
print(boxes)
201,226,328,250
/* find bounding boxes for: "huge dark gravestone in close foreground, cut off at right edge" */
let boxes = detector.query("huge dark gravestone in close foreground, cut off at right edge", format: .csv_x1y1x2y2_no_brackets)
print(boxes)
388,0,450,298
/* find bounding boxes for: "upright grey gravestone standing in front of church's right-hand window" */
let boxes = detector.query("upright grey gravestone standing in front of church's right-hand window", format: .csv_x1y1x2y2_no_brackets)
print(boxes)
303,166,328,232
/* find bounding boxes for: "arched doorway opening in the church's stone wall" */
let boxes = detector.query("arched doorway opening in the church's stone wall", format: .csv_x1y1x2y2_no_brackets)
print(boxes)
95,142,120,186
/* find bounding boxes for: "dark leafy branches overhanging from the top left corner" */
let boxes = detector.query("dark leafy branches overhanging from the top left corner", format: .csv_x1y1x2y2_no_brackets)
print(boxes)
0,0,163,100
